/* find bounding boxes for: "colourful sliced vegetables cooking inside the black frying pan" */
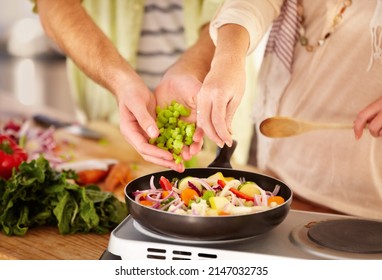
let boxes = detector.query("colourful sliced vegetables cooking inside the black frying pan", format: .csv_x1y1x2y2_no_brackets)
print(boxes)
133,172,285,216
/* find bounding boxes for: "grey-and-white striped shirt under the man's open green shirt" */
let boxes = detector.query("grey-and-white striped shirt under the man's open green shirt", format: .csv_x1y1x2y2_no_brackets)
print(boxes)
136,0,185,90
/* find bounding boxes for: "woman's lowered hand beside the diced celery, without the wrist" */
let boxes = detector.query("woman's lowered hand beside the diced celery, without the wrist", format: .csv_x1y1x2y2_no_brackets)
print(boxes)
197,56,245,147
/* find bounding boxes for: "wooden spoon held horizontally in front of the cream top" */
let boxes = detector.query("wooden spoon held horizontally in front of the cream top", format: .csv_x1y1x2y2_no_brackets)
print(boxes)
260,116,353,138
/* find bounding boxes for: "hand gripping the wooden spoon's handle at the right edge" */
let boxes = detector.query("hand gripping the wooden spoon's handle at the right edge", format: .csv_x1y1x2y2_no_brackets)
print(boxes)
354,98,382,139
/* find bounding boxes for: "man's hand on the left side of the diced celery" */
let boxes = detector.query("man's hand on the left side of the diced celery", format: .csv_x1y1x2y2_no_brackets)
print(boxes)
115,76,178,168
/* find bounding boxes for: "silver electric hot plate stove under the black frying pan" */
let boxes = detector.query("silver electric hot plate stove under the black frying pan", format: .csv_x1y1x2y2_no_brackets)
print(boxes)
100,210,382,260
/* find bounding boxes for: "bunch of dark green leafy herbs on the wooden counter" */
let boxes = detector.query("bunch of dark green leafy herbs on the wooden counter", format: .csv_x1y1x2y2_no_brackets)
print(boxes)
0,156,128,236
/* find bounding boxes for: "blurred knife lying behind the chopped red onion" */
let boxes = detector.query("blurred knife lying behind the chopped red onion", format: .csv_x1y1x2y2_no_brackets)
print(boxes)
32,114,103,140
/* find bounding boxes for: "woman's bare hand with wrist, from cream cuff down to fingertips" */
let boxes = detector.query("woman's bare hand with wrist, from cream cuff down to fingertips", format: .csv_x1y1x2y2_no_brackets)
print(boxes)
197,24,249,147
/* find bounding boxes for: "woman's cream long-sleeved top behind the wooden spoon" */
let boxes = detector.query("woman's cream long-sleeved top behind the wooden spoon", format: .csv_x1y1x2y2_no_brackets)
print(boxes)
211,0,382,219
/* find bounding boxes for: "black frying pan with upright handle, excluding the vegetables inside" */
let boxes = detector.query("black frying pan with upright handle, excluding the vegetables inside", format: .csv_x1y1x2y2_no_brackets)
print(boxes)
125,142,292,241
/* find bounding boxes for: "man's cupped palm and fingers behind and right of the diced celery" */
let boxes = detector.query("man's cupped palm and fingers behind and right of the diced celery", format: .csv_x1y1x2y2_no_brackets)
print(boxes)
154,74,203,172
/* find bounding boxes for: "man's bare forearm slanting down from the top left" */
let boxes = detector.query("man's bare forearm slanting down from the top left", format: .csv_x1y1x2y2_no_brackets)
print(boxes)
37,0,135,92
